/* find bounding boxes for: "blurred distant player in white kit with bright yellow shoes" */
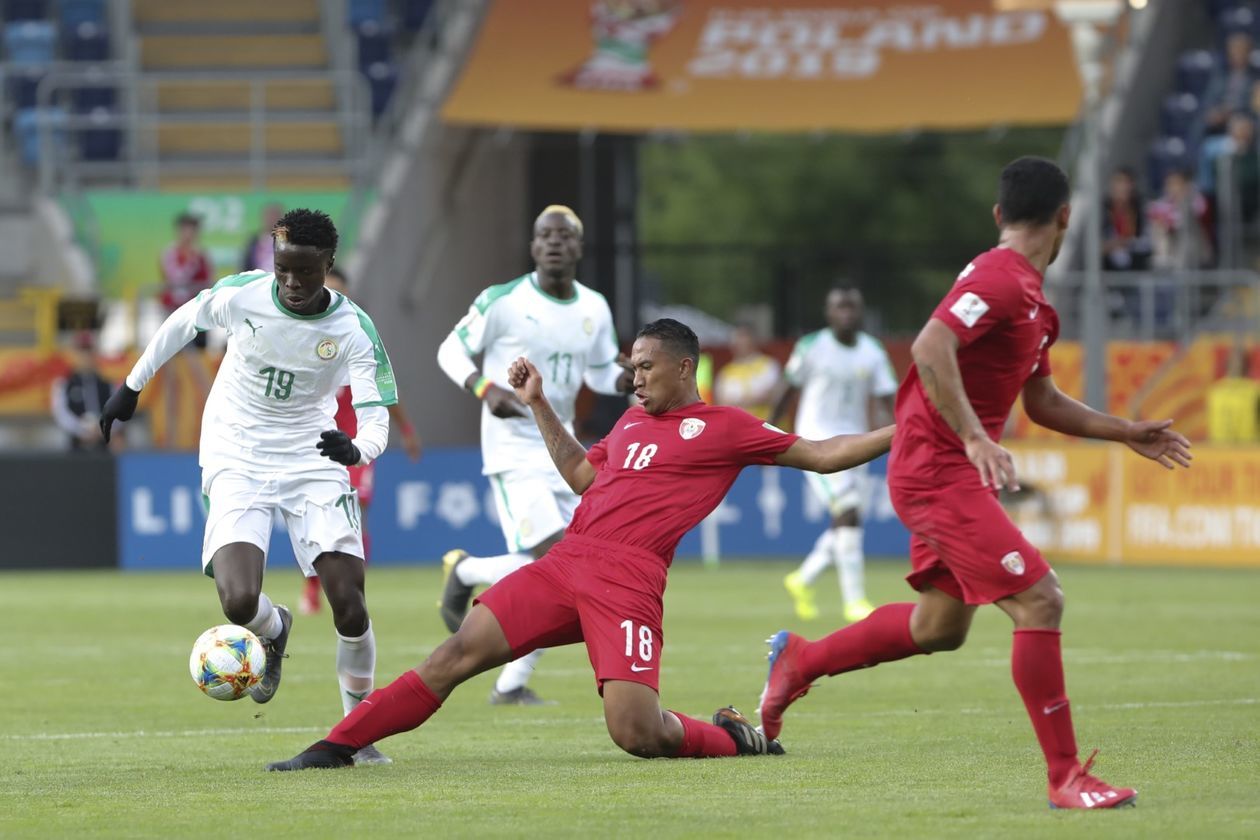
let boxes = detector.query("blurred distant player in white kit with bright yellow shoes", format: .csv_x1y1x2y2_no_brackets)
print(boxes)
770,286,897,621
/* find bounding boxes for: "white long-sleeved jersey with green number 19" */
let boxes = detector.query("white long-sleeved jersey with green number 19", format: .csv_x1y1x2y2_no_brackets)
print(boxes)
127,271,398,477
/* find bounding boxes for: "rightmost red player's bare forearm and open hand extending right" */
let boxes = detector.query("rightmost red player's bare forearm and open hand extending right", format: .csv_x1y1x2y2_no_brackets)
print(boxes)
1023,377,1193,470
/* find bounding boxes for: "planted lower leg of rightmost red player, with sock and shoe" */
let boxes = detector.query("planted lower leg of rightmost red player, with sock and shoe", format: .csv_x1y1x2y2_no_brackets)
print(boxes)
997,572,1138,809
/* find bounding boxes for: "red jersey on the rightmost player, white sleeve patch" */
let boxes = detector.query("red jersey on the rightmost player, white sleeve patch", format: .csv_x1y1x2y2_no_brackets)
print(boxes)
888,248,1058,485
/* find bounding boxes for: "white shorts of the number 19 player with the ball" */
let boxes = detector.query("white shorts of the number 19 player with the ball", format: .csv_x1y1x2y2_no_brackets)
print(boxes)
202,470,363,577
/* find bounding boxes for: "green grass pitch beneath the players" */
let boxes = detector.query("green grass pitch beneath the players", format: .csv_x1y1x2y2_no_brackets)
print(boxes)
0,563,1260,840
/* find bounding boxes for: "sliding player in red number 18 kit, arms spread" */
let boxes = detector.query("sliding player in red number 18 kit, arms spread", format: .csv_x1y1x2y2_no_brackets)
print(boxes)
267,319,892,771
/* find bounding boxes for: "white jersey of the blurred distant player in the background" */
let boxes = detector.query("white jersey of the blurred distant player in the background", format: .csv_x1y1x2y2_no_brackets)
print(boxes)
784,330,897,440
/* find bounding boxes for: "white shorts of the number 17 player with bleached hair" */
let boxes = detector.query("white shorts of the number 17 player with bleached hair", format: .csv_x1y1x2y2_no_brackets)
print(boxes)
486,470,582,552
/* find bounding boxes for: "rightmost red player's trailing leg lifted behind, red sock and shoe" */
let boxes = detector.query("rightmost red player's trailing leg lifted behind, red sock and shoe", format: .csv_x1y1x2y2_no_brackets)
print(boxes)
759,587,975,738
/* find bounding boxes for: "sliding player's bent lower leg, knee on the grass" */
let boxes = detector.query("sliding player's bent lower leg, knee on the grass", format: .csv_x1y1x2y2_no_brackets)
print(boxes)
604,680,784,758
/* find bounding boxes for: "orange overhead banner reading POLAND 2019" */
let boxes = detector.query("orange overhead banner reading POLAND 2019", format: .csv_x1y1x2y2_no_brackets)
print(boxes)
442,0,1081,132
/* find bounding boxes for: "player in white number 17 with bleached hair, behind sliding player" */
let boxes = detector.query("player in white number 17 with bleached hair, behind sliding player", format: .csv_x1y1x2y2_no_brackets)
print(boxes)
437,204,633,705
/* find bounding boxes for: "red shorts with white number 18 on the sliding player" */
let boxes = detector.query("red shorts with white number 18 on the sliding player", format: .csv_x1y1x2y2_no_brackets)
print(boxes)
476,534,668,694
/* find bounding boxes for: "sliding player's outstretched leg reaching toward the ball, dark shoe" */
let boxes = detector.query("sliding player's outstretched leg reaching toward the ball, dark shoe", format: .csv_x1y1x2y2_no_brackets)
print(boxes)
267,604,512,771
